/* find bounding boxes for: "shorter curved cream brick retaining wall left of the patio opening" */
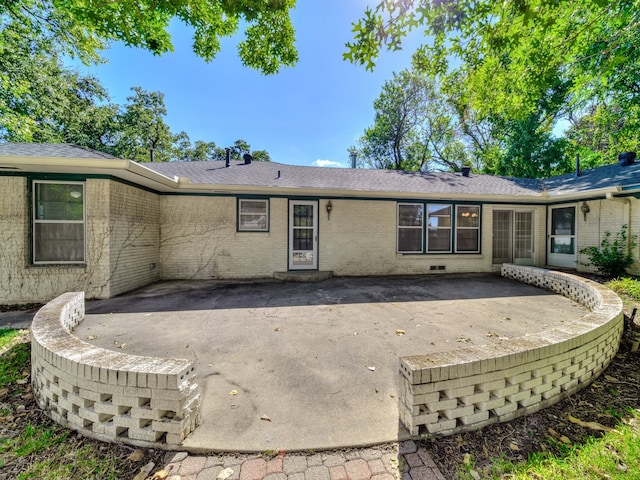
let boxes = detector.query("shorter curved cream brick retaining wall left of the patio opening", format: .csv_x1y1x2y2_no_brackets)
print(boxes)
31,292,200,448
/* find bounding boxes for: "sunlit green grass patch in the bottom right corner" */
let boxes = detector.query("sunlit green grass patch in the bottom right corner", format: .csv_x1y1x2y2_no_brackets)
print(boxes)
476,410,640,480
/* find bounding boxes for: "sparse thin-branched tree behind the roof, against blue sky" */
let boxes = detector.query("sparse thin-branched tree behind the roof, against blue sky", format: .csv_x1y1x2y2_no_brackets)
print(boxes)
360,70,466,171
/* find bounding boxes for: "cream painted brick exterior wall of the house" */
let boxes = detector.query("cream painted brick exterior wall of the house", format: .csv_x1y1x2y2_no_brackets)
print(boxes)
0,176,640,304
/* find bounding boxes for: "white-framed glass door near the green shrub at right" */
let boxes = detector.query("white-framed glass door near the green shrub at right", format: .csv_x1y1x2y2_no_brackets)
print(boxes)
547,205,578,268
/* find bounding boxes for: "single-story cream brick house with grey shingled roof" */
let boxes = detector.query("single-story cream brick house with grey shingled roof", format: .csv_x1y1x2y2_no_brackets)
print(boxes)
0,143,640,304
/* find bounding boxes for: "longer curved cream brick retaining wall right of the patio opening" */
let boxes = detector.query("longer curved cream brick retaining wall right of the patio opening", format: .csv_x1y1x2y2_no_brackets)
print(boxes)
399,265,624,435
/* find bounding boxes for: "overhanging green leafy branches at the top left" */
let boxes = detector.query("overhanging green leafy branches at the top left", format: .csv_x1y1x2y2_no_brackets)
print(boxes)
0,0,298,74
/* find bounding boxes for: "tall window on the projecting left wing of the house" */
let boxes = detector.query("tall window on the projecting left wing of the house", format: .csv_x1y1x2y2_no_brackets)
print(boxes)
32,181,85,264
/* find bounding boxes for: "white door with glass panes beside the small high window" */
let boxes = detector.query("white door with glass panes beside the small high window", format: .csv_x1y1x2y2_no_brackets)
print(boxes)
289,200,318,270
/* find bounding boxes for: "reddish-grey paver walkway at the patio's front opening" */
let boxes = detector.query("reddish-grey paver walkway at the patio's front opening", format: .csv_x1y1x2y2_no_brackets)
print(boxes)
157,440,446,480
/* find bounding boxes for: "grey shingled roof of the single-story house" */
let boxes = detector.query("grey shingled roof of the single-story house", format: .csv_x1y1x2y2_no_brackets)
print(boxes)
0,143,640,197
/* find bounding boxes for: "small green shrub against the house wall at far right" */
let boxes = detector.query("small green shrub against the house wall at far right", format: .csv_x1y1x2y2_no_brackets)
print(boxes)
580,225,636,278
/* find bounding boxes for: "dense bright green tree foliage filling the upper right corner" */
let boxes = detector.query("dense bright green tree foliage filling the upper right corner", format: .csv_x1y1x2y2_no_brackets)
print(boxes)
344,0,640,177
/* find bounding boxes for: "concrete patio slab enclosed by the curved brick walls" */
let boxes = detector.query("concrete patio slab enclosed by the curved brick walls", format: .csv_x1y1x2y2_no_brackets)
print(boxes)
13,275,588,452
